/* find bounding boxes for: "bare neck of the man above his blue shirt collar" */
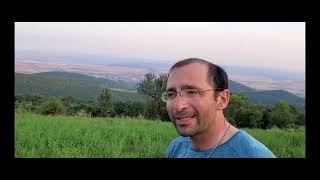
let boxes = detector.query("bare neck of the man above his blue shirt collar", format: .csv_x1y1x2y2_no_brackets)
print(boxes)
190,115,229,149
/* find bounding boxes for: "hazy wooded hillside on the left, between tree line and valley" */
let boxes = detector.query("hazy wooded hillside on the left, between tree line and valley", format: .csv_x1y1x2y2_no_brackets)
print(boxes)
15,72,147,101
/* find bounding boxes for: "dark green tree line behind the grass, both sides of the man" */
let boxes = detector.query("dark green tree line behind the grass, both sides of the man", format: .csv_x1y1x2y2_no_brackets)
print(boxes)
15,73,305,129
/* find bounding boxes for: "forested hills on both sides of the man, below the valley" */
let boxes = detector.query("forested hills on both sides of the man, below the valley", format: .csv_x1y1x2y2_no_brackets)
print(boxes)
15,72,305,108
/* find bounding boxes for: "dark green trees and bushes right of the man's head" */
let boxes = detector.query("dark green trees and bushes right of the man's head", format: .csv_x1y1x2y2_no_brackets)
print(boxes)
224,93,305,129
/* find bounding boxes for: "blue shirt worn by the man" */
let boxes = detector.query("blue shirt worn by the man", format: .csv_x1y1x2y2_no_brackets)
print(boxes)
165,130,276,158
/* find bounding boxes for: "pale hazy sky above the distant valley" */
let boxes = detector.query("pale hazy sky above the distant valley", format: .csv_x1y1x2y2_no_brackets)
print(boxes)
15,22,305,72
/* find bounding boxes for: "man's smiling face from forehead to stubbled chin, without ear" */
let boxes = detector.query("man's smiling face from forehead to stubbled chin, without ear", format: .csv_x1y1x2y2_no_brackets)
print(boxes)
167,63,217,137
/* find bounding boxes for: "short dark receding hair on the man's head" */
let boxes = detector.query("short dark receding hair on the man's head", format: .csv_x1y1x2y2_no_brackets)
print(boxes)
169,58,228,97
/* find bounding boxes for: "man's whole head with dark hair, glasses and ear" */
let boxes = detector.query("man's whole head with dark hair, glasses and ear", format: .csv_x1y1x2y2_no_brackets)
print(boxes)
167,58,230,136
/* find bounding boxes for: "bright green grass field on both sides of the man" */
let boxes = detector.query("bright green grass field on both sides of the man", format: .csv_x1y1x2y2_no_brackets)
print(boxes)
15,113,305,158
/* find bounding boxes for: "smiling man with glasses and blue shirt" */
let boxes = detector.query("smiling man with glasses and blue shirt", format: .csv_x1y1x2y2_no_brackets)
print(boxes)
162,58,275,158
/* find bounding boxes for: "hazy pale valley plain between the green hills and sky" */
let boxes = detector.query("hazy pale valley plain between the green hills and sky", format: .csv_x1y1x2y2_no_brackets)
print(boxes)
15,51,305,106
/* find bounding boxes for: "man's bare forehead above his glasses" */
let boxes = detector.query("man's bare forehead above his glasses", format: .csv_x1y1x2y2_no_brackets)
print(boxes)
167,62,211,89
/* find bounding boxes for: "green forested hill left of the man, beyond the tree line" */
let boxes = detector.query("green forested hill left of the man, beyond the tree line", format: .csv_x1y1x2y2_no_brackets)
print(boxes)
15,73,148,101
